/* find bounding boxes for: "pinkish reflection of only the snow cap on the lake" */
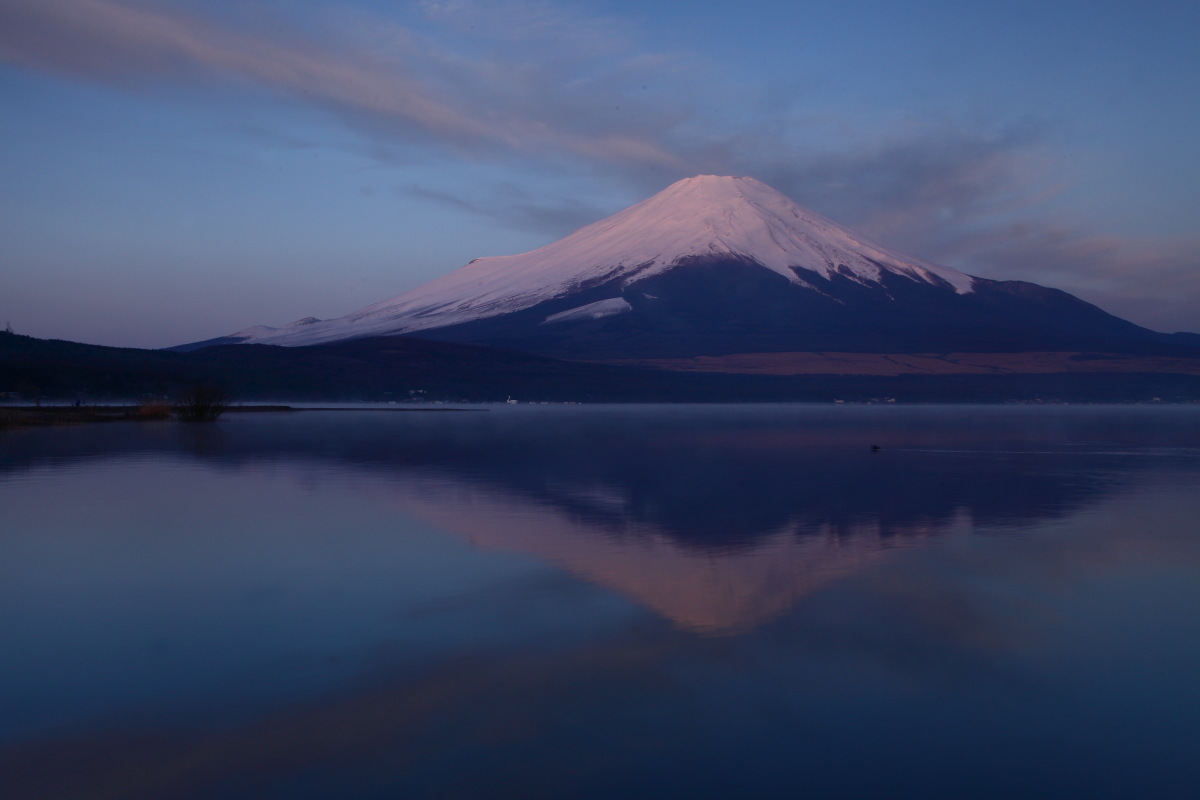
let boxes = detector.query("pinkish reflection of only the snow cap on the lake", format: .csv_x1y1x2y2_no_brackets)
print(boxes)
388,481,970,633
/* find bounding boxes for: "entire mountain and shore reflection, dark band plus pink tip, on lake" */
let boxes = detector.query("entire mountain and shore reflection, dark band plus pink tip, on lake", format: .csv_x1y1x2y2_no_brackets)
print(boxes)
0,407,1196,632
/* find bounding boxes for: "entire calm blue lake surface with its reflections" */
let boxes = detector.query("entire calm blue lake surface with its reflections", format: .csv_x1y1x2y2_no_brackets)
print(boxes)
0,407,1200,799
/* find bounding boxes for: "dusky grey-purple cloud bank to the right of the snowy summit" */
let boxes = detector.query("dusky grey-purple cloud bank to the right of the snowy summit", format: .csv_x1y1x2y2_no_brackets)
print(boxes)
761,124,1200,331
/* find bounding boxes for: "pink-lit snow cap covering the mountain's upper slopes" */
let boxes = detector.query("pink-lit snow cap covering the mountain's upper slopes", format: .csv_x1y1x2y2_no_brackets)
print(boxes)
223,175,973,344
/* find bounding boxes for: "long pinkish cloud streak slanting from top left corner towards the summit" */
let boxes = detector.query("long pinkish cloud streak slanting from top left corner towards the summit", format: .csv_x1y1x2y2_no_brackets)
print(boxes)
0,0,680,166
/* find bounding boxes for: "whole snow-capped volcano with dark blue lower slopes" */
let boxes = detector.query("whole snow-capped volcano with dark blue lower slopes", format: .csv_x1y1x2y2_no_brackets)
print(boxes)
192,175,1200,361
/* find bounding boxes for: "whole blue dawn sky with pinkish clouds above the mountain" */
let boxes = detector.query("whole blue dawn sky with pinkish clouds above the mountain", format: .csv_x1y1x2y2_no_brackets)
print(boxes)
0,0,1200,347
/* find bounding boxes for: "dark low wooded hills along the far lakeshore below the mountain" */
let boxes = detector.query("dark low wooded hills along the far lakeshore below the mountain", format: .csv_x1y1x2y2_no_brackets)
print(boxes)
7,332,1200,403
